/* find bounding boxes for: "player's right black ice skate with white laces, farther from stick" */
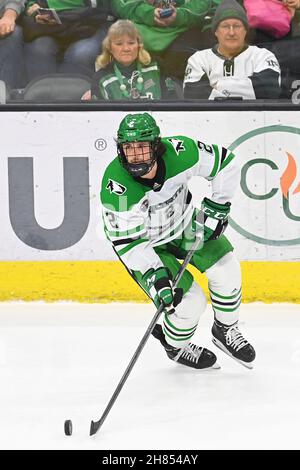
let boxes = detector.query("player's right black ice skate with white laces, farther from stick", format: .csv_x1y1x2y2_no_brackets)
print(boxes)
211,320,255,369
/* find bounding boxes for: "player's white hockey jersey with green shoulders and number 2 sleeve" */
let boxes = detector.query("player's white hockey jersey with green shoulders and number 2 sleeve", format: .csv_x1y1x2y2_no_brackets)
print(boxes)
101,136,240,273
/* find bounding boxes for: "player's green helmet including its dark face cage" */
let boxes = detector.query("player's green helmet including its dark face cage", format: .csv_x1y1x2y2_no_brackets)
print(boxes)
117,113,161,177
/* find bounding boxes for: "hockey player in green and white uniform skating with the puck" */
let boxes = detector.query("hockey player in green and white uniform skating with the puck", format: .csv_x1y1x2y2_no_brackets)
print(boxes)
101,113,255,369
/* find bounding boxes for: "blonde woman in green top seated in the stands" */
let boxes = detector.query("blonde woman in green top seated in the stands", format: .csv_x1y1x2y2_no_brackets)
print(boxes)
83,20,176,100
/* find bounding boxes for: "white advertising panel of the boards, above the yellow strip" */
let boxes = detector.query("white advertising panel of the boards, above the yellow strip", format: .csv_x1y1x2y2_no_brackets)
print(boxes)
0,111,300,302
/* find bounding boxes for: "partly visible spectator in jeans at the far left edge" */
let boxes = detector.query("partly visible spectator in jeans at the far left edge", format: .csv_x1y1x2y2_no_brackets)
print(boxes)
0,0,25,88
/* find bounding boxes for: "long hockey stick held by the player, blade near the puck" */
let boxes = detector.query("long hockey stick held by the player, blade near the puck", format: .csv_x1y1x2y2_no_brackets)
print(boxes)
90,237,203,436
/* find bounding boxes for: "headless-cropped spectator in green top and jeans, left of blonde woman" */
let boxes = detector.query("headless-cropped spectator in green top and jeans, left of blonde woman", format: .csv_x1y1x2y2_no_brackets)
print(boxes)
22,0,110,81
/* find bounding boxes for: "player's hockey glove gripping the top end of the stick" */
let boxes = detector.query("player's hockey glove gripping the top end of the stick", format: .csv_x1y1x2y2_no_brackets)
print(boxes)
201,197,231,242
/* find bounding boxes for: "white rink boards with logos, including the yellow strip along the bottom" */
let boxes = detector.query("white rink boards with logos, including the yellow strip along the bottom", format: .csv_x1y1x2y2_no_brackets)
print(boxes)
0,110,300,303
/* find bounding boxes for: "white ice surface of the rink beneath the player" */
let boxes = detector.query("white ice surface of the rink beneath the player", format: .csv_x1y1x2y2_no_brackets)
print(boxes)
0,303,300,450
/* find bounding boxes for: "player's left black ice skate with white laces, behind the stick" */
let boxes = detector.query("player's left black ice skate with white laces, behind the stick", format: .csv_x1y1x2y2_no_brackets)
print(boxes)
152,324,220,369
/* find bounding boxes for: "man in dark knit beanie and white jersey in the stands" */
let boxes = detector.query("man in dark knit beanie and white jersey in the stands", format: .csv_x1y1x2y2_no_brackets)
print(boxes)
184,0,280,100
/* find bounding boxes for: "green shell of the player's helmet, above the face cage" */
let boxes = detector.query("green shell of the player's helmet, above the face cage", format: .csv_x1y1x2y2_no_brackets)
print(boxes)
118,113,160,144
